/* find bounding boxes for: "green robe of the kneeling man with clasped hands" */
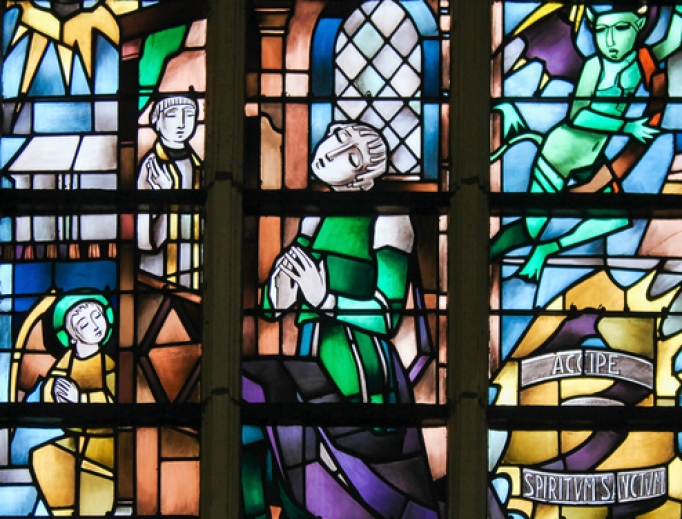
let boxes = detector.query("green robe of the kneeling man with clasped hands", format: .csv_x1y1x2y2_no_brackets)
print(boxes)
263,216,409,403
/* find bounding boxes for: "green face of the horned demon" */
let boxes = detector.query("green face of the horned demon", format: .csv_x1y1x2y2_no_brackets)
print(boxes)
594,13,641,61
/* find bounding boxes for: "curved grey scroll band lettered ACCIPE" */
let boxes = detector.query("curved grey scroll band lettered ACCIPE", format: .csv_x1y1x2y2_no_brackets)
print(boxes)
521,348,654,389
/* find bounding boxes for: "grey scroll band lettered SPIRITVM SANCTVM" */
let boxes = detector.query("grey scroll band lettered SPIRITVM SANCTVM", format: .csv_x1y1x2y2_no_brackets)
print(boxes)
522,468,667,506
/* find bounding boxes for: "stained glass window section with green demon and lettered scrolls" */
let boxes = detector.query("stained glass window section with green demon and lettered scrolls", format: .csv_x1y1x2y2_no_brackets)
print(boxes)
488,1,682,519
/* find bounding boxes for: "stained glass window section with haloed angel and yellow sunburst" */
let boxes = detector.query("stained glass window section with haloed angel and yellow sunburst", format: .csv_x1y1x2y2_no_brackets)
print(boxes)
0,0,206,516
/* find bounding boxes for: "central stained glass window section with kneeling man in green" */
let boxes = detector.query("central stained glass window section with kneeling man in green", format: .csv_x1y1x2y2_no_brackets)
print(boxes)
242,0,449,518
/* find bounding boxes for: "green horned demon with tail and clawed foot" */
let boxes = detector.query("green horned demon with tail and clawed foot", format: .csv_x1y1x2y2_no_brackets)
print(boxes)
490,2,682,282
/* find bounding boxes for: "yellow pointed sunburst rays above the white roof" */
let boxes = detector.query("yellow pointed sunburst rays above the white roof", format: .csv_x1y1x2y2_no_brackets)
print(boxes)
8,0,120,94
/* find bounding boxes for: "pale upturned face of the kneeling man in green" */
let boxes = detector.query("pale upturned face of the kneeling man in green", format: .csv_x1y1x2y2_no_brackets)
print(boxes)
312,127,370,190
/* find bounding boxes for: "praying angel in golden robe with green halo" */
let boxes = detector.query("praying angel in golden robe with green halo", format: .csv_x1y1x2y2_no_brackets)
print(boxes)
30,291,116,515
